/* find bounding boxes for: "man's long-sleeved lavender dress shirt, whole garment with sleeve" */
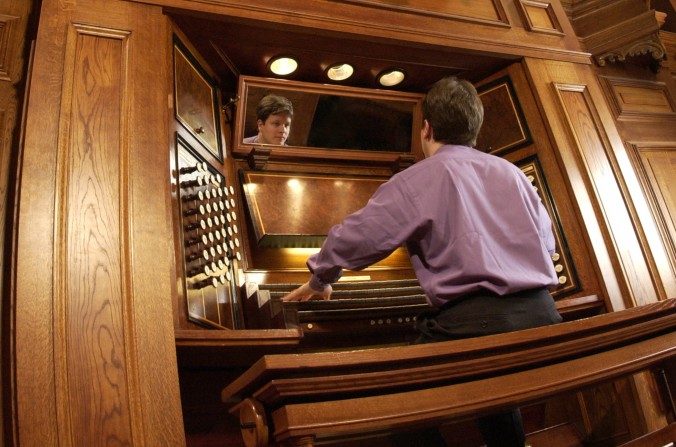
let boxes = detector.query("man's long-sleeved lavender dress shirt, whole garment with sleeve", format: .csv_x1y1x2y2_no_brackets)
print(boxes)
307,145,557,307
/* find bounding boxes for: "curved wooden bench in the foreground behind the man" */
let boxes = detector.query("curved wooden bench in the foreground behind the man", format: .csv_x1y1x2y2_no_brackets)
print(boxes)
221,299,676,446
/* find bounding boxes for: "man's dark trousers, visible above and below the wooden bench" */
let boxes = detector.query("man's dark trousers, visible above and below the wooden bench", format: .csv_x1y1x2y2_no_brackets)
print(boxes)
393,288,561,447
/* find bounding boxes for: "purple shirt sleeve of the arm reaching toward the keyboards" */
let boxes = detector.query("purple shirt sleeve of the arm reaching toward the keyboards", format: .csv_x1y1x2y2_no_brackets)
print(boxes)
307,176,424,291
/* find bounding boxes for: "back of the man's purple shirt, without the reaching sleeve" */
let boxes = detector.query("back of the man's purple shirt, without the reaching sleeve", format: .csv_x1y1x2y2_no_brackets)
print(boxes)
394,146,556,305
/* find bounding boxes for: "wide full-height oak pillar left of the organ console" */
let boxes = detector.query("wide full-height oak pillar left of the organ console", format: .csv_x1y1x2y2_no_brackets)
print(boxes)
15,0,185,445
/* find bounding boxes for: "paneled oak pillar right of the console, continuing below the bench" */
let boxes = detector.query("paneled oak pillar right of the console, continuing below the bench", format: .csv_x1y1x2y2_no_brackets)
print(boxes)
525,59,673,436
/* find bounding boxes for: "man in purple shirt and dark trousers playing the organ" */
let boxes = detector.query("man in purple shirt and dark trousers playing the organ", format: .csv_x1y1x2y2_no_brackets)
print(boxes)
282,78,561,447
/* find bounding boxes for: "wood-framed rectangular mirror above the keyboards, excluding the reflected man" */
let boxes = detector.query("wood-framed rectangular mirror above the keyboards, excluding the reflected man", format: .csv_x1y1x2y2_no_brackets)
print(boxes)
234,76,422,158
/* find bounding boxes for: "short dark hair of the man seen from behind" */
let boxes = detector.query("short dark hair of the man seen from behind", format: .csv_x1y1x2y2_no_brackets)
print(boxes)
423,76,484,146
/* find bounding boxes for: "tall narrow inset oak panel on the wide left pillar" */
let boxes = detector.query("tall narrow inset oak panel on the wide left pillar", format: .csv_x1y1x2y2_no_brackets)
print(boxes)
57,26,132,445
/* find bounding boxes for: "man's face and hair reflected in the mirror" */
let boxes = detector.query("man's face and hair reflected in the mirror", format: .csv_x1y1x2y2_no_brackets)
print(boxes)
243,94,293,145
